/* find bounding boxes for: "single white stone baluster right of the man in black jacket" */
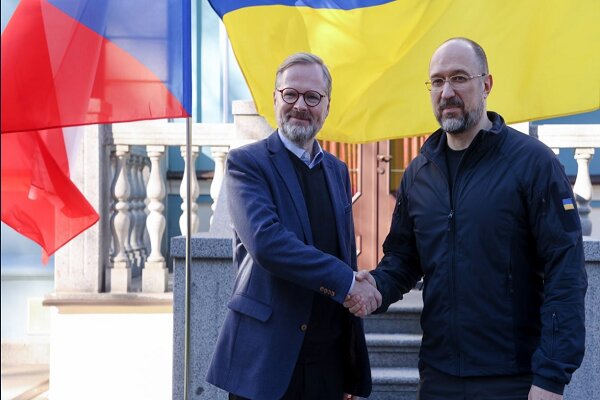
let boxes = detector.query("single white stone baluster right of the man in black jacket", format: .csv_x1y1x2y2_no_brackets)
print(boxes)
573,148,594,236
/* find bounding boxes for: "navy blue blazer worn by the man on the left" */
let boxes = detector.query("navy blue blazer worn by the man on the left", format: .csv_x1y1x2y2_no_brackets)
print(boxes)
207,132,371,400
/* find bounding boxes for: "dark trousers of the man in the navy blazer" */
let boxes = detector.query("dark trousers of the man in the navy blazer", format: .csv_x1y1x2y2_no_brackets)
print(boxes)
229,363,344,400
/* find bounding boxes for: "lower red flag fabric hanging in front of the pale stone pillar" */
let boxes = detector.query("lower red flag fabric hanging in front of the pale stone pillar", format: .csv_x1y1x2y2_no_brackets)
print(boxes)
1,128,99,258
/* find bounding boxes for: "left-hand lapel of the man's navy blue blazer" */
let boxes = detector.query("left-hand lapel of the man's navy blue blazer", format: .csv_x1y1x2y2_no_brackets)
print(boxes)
267,131,313,244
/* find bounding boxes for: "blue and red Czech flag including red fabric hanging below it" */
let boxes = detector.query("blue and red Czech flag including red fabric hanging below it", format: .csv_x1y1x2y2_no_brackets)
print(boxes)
1,0,191,255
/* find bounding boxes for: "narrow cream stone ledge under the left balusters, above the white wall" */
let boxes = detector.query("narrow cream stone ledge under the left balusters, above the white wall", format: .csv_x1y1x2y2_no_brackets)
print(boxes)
42,292,173,307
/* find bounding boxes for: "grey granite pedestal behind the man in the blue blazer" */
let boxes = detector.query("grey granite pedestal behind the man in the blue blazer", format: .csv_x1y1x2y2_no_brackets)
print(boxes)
171,236,235,400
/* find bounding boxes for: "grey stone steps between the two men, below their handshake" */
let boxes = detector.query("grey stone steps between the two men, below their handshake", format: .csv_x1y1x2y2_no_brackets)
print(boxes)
364,290,423,400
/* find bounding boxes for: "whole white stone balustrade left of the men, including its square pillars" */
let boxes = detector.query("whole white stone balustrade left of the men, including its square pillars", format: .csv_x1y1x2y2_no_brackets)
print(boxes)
55,101,271,297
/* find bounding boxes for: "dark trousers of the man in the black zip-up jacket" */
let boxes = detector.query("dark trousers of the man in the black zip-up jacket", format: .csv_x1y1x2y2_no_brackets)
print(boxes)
417,361,533,400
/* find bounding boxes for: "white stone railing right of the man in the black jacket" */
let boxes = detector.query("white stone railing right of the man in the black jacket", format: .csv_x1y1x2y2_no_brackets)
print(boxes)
537,124,600,236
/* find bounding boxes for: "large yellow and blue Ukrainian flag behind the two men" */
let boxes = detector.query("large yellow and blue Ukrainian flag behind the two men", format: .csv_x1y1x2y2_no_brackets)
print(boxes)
210,0,600,143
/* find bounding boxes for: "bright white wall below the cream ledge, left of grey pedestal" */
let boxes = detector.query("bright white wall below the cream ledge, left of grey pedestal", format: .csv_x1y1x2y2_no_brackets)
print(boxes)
49,306,173,400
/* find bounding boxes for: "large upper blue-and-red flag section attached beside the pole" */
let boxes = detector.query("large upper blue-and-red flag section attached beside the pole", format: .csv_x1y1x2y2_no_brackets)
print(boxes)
2,0,191,134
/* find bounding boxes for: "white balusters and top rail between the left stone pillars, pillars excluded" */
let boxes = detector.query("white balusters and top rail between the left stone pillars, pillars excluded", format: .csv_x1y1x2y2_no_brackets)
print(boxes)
107,121,234,293
